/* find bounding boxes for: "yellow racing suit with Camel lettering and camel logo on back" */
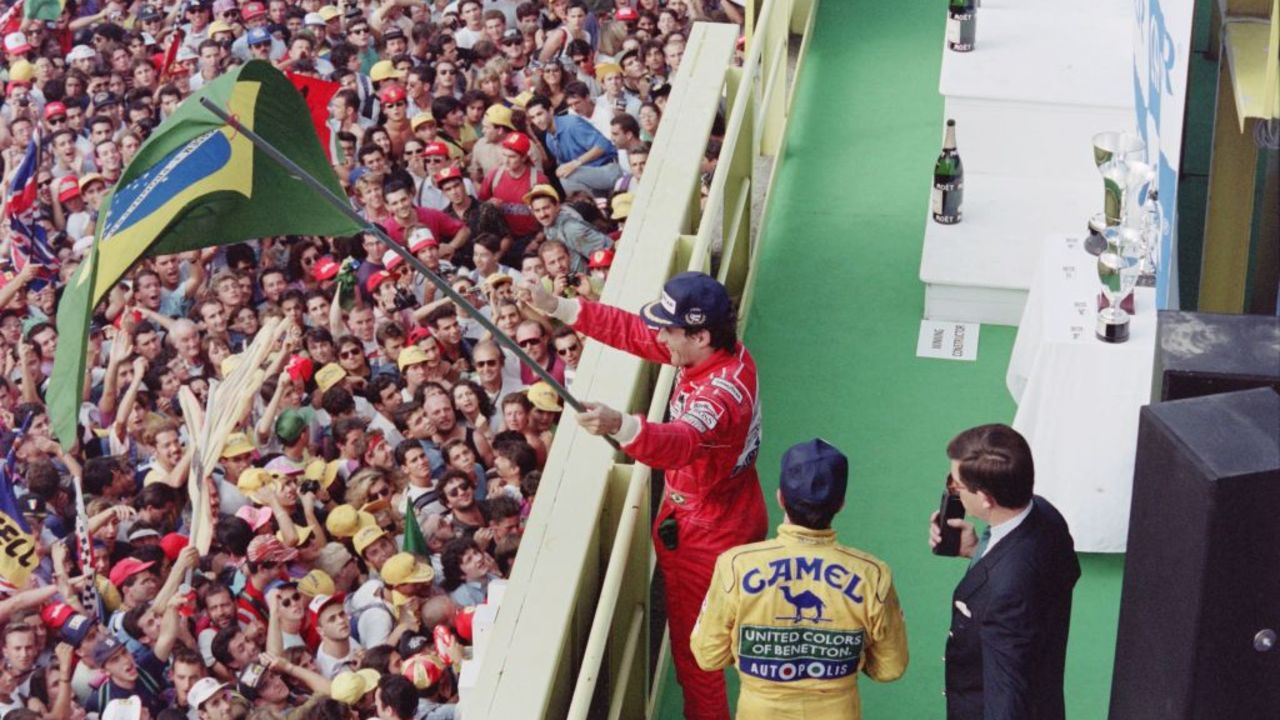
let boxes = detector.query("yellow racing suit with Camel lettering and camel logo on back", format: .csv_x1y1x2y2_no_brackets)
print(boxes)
691,524,908,720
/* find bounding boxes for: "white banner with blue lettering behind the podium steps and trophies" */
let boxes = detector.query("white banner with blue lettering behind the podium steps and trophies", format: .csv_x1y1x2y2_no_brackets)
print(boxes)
1133,0,1194,309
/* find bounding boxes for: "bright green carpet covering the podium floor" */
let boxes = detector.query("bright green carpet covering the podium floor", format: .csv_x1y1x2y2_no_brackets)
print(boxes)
658,0,1123,719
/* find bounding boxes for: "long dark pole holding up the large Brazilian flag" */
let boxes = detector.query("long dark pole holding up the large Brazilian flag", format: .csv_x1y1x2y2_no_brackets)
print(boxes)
200,97,622,450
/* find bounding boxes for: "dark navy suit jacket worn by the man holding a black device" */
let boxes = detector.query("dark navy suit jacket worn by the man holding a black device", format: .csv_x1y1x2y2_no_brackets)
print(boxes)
946,496,1080,720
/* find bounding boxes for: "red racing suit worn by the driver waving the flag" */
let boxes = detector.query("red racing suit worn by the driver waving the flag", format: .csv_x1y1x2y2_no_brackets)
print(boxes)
573,301,768,720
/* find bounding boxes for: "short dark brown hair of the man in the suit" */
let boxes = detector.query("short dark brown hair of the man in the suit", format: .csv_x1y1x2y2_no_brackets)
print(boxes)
947,424,1036,510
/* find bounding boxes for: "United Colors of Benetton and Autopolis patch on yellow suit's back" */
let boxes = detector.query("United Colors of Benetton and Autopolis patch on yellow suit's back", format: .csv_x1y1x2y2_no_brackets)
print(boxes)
737,625,865,683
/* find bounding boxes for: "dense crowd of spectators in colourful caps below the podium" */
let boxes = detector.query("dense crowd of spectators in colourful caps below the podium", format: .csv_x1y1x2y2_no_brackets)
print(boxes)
0,0,742,720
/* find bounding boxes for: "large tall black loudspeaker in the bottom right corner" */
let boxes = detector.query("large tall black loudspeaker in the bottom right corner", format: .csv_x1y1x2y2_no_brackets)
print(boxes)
1111,388,1280,720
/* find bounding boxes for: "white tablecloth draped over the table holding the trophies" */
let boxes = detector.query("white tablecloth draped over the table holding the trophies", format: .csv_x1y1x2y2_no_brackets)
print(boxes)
1005,237,1156,552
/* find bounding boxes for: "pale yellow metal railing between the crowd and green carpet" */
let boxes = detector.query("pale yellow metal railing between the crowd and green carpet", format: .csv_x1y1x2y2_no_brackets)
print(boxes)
462,0,815,720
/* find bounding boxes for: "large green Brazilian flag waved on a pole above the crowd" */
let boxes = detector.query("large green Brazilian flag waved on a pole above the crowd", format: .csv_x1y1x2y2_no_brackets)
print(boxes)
47,60,361,448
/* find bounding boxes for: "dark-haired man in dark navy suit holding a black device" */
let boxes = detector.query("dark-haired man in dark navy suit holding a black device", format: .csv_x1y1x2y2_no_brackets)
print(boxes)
929,425,1080,720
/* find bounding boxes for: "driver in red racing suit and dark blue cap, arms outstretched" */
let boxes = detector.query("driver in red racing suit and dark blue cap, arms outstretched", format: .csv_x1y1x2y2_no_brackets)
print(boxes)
524,273,768,720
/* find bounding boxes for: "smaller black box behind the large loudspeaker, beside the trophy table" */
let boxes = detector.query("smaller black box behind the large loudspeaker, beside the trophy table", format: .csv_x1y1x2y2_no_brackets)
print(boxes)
1151,310,1280,402
